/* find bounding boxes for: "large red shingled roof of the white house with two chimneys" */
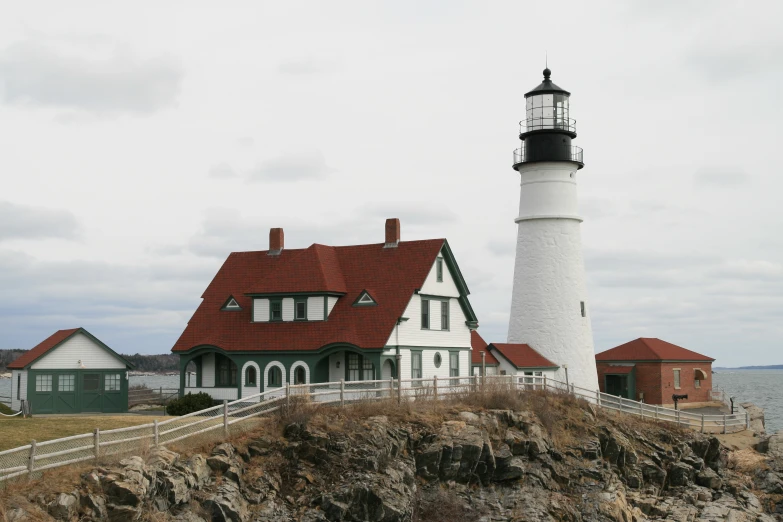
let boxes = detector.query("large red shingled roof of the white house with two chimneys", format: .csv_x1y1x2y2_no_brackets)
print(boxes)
172,239,445,352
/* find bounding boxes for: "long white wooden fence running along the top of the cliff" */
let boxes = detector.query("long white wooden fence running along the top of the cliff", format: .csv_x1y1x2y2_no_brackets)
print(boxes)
0,375,749,481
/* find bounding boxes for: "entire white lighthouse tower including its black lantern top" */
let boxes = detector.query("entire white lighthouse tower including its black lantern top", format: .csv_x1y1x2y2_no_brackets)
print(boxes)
508,69,598,390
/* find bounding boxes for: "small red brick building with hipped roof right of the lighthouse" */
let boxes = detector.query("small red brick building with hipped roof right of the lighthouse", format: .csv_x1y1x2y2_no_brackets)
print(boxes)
595,337,715,407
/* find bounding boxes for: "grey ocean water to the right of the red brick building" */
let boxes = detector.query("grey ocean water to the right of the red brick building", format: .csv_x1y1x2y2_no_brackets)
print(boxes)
712,369,783,433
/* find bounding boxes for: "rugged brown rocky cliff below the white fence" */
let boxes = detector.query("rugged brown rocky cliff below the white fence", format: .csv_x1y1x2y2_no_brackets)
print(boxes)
0,395,783,522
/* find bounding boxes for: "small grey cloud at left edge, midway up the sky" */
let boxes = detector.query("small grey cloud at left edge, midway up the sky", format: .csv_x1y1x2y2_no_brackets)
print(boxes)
0,201,80,241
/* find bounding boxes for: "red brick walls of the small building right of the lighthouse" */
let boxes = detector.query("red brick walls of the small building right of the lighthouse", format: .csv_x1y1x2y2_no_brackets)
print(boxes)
596,362,712,404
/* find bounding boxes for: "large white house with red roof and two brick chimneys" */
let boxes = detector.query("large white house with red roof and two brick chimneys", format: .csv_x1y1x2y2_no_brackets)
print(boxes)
172,219,478,400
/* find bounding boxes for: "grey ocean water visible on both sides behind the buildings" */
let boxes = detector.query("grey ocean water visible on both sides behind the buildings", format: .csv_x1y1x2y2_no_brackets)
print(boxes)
0,370,783,433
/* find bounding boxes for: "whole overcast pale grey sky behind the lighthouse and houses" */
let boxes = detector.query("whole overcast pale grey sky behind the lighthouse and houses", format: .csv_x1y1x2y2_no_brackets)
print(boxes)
0,0,783,366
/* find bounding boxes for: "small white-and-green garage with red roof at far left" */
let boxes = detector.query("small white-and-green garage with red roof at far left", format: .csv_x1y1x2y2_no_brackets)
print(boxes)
8,328,133,414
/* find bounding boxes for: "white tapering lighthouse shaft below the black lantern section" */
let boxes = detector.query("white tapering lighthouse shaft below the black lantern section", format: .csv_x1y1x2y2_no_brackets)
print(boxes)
508,161,598,391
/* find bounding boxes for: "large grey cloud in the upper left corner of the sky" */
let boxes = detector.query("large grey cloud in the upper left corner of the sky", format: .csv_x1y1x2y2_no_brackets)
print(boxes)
0,39,183,115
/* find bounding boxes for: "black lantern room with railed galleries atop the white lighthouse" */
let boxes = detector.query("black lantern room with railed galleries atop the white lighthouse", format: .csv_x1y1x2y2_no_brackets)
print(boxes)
514,68,584,170
